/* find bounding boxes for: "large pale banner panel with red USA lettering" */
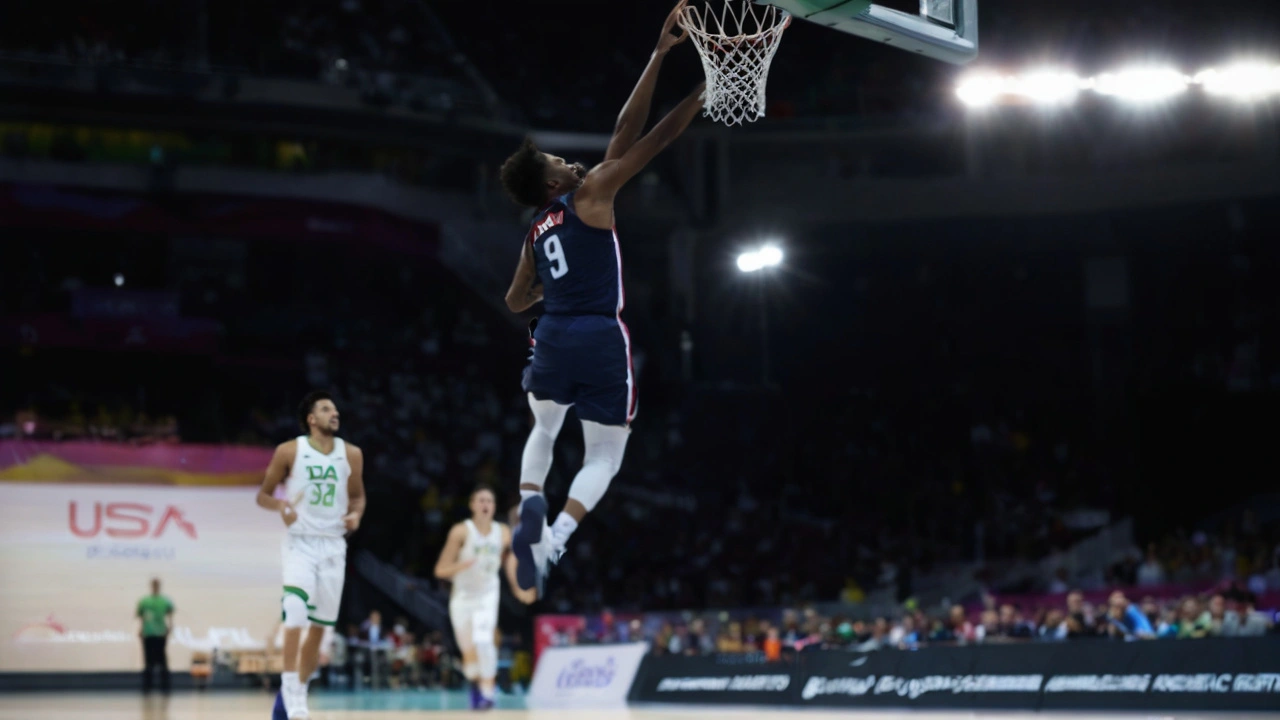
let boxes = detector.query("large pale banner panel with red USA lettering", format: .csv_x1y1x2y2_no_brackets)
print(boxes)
0,483,284,673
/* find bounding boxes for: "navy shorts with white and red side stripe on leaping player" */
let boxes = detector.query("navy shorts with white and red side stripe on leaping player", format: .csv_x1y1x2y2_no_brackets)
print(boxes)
521,315,636,425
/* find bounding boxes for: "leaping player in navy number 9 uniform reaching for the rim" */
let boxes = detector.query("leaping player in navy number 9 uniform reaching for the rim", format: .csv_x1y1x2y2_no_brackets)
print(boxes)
502,1,705,594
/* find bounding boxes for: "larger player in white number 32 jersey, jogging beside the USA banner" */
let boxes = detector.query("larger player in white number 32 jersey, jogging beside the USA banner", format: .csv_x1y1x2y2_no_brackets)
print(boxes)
257,392,365,720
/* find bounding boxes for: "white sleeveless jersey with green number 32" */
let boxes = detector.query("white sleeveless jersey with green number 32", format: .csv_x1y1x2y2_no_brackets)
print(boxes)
284,436,351,538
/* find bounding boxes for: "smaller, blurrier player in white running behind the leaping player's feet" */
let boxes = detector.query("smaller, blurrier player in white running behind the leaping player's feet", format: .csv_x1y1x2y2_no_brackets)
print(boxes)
435,487,538,710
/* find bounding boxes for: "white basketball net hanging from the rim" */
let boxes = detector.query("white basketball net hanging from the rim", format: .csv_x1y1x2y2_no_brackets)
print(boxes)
680,0,791,127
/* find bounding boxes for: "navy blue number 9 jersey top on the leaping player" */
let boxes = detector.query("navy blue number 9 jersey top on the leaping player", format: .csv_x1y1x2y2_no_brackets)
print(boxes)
526,192,623,316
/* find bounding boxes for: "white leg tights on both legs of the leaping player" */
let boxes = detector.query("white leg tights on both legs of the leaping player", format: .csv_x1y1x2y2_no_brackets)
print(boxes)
520,393,631,512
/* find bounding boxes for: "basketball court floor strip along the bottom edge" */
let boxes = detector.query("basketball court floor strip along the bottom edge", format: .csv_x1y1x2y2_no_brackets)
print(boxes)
0,692,1280,720
